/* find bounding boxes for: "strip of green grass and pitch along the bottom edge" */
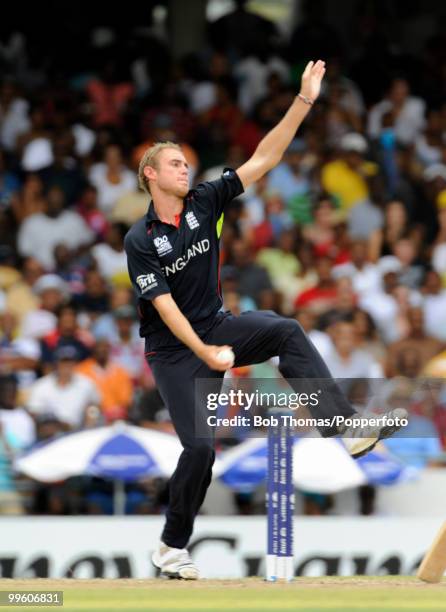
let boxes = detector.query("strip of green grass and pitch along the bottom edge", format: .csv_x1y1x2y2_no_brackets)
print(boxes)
0,576,446,612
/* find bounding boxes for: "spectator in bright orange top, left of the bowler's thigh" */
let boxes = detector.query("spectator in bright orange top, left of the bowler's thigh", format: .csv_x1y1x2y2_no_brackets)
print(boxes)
76,339,133,422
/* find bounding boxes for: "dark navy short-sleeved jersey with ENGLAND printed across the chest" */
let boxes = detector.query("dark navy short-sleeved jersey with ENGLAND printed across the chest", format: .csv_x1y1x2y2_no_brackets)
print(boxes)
124,168,243,337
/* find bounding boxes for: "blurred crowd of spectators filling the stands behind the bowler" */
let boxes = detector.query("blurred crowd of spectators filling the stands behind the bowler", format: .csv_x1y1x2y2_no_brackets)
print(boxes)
0,3,446,513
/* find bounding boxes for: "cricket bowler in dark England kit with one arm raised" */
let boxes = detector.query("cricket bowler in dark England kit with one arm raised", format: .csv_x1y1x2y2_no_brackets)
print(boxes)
125,60,406,580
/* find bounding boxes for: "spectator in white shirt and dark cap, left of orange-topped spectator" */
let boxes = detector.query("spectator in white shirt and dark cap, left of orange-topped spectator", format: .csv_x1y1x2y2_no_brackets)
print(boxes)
27,346,100,430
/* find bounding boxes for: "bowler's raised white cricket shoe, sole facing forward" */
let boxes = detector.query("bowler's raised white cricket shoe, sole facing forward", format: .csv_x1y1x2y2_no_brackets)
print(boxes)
340,408,408,459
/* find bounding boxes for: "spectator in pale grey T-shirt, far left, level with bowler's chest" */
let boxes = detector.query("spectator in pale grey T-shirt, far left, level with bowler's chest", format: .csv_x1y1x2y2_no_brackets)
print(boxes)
17,187,93,271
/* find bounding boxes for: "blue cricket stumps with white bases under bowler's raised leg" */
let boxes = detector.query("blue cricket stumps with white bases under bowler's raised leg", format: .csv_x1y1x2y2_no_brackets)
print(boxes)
266,408,294,582
